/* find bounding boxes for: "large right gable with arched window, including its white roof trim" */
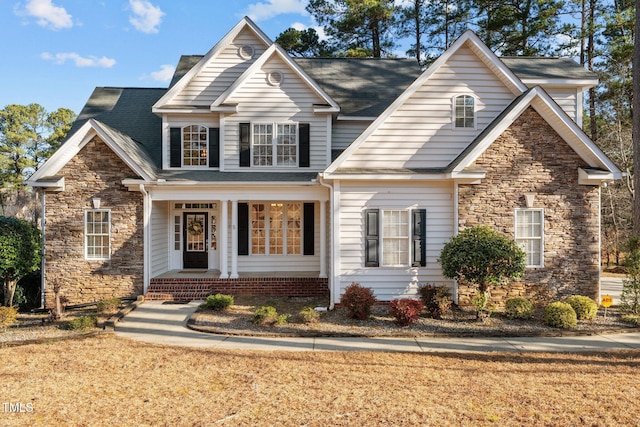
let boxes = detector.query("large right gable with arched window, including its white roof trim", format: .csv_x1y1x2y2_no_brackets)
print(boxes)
328,31,526,172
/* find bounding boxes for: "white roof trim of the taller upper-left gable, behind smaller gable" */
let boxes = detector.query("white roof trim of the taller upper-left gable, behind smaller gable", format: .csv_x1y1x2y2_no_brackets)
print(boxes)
153,16,273,112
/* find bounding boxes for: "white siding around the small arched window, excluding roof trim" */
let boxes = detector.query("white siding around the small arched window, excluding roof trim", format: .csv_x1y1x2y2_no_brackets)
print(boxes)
343,47,514,168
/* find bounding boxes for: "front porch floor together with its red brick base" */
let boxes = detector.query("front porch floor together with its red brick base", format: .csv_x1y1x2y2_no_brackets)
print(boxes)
145,269,329,301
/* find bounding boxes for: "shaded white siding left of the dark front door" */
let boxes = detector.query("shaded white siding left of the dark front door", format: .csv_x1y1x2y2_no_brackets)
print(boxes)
151,202,170,277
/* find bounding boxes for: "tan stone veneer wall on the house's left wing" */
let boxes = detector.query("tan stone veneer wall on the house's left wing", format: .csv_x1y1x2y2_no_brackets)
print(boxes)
45,137,144,307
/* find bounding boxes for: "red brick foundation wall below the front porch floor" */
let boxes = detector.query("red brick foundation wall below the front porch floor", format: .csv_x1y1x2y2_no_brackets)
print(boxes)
145,277,329,300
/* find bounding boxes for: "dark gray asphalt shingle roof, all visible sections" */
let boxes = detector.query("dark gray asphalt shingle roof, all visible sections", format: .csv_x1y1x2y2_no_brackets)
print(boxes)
69,55,596,181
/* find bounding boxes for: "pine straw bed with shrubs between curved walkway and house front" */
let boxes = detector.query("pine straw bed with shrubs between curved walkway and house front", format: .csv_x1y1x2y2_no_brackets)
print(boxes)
189,296,640,337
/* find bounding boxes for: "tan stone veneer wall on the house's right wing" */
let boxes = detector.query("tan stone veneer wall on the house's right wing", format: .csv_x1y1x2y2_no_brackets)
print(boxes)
458,107,600,304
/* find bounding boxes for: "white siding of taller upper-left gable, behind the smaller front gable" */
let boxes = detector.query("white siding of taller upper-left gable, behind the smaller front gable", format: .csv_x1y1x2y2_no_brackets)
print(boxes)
168,31,266,107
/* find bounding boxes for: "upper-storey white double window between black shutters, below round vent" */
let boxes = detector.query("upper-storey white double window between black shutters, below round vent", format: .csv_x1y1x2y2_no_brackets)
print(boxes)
252,123,298,167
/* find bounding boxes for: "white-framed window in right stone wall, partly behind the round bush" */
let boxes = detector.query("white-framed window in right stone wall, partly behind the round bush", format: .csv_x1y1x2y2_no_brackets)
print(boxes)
515,208,544,268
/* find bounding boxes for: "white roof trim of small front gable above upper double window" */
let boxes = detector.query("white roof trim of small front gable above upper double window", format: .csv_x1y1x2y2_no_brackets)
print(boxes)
211,43,340,112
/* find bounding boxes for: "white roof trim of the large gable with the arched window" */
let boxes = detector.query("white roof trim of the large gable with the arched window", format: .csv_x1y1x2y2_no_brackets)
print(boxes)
326,30,527,173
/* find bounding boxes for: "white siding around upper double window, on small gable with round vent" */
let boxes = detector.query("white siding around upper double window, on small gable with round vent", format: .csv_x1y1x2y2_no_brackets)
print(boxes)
221,58,328,172
